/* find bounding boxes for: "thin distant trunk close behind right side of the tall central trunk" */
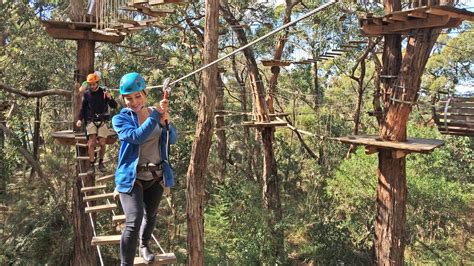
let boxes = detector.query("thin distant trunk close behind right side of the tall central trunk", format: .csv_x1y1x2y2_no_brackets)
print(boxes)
216,78,227,184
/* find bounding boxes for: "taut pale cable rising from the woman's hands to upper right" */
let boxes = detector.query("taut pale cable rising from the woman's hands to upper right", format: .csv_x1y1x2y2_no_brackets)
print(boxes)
147,0,338,89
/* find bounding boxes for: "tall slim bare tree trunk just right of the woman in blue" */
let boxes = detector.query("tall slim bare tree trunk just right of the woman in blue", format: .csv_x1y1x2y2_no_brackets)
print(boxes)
186,0,219,265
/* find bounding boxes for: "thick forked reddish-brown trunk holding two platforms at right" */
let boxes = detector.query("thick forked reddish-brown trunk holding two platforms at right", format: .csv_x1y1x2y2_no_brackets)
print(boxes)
375,1,441,265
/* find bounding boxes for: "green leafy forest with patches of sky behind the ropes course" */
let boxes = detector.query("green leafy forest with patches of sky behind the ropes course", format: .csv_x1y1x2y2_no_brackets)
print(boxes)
0,0,474,265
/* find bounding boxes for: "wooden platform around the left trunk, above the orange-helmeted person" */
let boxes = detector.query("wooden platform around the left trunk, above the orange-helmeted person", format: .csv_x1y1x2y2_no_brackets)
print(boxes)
41,20,125,43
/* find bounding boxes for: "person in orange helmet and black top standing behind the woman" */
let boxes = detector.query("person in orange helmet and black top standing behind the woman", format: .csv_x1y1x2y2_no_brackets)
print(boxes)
76,73,117,173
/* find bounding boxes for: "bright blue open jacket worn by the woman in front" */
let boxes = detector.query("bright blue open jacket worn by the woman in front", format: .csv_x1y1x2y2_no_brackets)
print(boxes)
112,108,176,193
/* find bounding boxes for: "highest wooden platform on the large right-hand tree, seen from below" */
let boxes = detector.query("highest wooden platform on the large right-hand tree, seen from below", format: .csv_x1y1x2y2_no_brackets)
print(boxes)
359,6,474,36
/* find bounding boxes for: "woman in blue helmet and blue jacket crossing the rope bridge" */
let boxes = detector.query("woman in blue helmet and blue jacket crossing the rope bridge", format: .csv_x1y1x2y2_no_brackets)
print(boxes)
112,72,176,265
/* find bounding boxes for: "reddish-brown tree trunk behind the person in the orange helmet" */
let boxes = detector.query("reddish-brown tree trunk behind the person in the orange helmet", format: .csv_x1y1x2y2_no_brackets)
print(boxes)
71,40,97,265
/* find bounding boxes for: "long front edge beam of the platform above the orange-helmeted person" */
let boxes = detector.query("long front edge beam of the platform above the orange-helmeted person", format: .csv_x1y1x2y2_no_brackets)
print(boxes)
46,28,125,43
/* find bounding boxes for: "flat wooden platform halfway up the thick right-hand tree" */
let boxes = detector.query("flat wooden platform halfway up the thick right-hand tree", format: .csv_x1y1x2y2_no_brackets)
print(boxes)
335,135,444,153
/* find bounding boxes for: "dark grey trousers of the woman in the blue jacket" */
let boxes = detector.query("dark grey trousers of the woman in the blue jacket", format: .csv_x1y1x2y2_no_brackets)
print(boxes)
120,180,163,265
